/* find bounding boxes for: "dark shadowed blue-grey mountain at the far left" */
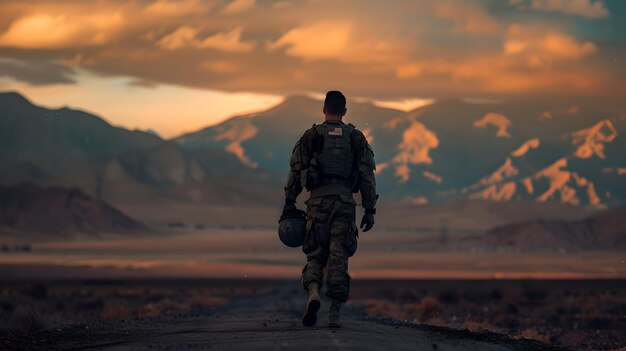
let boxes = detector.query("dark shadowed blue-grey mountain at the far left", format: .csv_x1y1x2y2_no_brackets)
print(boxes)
0,93,272,202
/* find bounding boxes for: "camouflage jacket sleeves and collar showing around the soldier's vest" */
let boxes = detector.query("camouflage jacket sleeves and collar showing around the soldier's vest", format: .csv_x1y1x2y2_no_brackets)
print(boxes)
285,121,378,209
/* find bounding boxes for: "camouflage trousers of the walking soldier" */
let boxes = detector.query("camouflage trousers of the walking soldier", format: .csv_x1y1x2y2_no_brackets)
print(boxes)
302,195,358,302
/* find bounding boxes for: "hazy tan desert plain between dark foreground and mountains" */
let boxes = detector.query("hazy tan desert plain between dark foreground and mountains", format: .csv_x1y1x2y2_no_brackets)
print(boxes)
0,227,626,279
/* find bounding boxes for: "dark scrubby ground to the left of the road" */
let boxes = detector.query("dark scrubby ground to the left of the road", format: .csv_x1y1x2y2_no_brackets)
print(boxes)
0,280,270,335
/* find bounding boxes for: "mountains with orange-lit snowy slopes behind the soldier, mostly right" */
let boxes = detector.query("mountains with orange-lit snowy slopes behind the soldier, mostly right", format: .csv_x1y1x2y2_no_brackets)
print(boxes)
174,96,626,207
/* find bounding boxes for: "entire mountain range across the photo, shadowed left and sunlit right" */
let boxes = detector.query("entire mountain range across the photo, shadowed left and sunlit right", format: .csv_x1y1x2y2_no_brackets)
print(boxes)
0,93,626,207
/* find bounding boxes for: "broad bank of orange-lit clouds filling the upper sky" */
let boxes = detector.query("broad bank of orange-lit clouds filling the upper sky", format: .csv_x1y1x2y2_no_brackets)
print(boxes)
0,0,626,100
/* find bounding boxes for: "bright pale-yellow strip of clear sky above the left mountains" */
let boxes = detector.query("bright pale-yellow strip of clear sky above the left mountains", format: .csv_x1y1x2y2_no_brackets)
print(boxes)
0,71,282,137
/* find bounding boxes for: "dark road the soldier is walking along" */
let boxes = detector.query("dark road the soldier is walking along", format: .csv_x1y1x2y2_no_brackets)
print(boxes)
0,281,551,351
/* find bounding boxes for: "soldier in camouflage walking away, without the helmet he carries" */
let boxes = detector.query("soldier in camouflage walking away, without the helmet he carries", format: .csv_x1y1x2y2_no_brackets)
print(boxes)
283,91,378,328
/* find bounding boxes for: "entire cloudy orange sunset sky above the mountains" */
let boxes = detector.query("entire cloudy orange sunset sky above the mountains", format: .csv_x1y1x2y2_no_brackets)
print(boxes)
0,0,626,137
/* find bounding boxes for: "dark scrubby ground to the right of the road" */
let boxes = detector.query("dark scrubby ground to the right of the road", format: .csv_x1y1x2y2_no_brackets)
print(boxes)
350,280,626,351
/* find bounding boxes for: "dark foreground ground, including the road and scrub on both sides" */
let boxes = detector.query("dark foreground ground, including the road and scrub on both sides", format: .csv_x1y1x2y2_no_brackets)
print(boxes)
0,279,626,350
